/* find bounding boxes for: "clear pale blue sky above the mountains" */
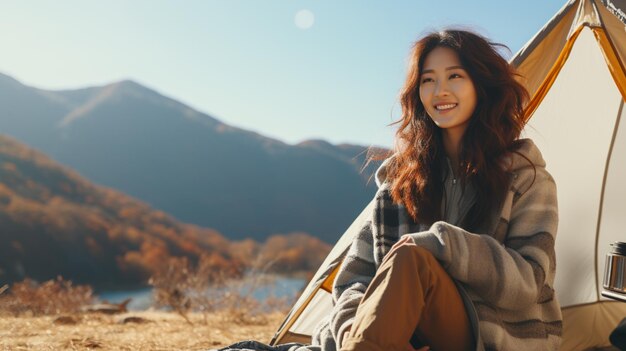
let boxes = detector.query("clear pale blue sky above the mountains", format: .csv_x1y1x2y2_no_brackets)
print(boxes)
0,0,565,146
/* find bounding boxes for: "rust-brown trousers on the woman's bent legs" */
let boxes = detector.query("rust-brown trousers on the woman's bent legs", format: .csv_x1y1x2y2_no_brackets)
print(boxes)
341,237,474,351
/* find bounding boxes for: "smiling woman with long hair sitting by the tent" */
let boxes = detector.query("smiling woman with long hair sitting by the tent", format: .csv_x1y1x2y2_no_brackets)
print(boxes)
314,30,562,351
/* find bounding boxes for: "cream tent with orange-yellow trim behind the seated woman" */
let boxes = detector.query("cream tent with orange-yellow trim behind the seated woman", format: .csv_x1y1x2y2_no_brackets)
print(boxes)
272,0,626,350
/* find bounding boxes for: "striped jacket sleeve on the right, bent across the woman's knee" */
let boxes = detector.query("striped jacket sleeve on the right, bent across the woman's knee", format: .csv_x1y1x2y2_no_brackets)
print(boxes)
406,167,558,310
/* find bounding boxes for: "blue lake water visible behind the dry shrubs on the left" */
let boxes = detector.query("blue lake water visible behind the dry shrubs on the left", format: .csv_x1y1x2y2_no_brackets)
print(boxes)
96,277,307,311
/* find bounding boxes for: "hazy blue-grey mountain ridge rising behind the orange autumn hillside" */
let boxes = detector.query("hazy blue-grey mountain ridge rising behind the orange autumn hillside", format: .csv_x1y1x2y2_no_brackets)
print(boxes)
0,75,388,243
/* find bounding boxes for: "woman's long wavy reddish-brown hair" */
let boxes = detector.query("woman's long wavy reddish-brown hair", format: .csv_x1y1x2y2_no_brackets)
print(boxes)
387,30,528,230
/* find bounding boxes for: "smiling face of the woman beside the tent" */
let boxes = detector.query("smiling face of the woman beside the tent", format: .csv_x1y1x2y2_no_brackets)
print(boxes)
419,47,476,136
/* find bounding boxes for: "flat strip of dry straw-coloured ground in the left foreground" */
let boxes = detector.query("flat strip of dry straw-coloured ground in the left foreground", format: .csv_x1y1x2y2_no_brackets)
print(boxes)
0,311,285,351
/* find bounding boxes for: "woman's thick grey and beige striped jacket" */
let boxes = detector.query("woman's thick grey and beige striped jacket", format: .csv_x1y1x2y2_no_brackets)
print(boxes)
313,139,562,351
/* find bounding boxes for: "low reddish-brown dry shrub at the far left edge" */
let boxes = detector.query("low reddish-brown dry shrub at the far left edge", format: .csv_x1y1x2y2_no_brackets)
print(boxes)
0,276,94,316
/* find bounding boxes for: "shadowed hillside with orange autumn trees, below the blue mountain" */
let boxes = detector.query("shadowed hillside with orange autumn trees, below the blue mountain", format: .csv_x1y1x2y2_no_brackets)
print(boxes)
0,135,330,286
